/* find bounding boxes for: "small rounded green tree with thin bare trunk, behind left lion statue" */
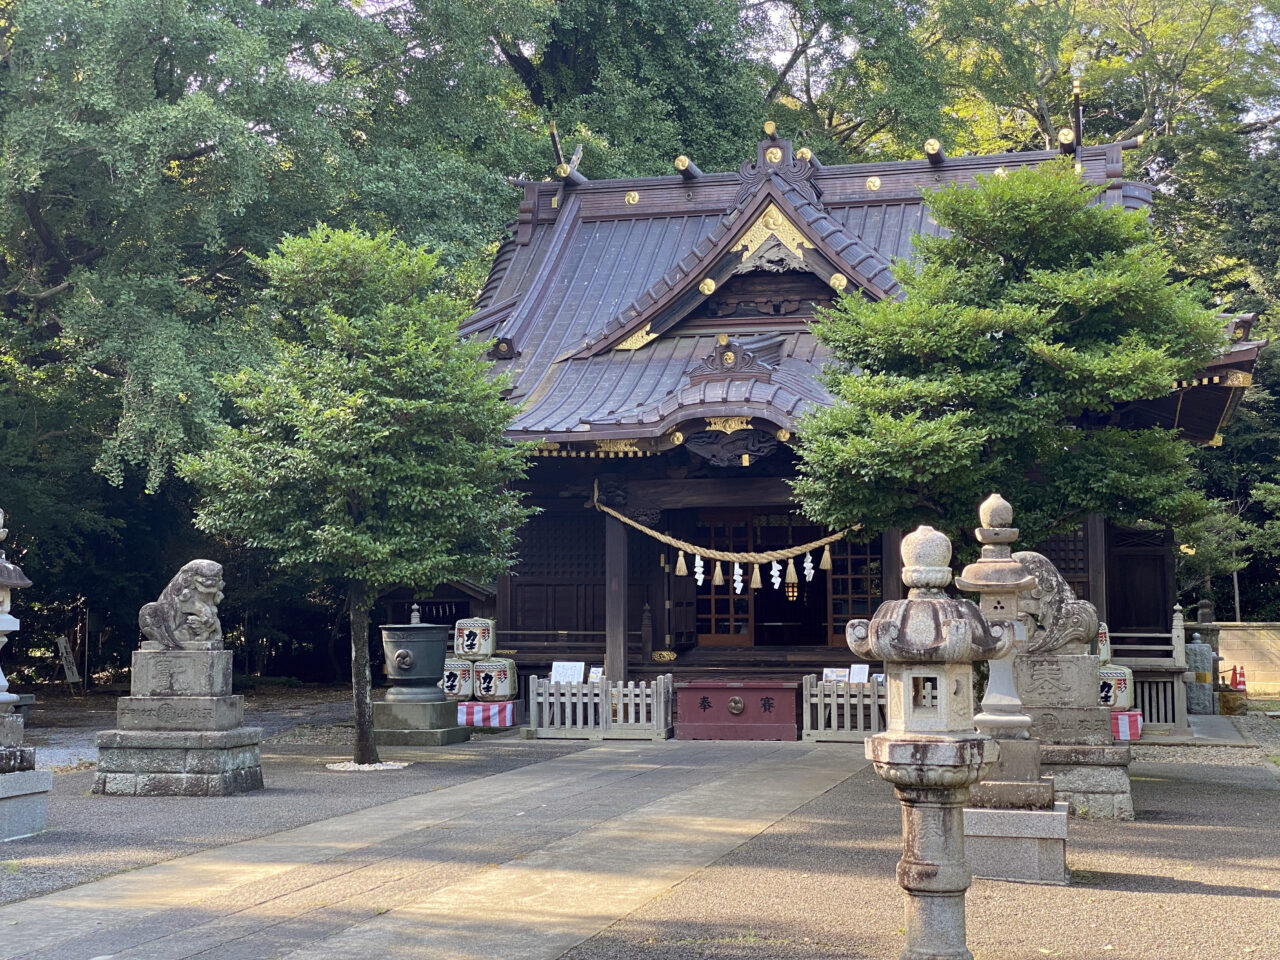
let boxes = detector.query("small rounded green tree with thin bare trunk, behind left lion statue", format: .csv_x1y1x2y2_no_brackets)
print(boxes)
180,228,529,763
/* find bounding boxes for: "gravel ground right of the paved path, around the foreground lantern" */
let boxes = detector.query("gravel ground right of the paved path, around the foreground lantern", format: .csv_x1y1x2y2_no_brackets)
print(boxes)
562,763,1280,960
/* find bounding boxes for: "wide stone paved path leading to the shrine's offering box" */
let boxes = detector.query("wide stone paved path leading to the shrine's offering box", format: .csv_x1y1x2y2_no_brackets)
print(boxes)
0,742,865,960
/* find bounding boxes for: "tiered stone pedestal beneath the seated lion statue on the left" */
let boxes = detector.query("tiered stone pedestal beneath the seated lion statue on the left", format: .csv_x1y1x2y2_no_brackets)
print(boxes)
93,650,262,796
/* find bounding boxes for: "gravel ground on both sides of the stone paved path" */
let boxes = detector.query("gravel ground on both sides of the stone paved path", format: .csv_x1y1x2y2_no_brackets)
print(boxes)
10,691,1280,960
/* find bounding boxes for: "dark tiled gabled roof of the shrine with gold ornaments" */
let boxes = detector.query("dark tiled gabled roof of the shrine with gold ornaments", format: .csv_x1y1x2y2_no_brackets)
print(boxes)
463,138,1149,452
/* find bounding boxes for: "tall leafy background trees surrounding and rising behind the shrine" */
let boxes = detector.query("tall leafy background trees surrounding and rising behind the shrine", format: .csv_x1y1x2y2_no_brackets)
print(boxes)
0,0,1280,675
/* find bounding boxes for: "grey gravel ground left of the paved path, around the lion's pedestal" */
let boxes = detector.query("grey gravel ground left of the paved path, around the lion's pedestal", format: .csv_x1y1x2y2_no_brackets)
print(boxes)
0,687,588,902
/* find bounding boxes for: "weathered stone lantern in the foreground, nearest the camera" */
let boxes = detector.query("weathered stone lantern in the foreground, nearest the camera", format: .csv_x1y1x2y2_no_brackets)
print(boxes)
846,526,1012,960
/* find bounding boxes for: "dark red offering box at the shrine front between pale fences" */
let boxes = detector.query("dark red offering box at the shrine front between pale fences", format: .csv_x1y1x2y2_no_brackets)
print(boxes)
676,680,800,740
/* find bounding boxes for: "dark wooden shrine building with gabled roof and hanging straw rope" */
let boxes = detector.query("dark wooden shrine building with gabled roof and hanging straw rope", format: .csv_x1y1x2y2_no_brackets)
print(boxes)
440,129,1263,680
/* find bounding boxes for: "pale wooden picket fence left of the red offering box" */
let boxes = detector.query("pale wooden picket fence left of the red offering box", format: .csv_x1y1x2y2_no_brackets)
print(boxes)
529,673,676,740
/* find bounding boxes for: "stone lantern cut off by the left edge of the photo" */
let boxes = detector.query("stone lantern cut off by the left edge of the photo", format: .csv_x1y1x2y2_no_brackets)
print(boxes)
0,511,54,841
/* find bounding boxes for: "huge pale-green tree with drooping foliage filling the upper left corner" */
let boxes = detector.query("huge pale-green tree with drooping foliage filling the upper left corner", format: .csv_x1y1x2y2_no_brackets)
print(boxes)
0,0,389,489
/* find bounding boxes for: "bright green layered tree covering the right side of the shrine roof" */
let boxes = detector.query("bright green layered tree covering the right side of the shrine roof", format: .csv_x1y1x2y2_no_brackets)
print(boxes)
795,161,1222,543
